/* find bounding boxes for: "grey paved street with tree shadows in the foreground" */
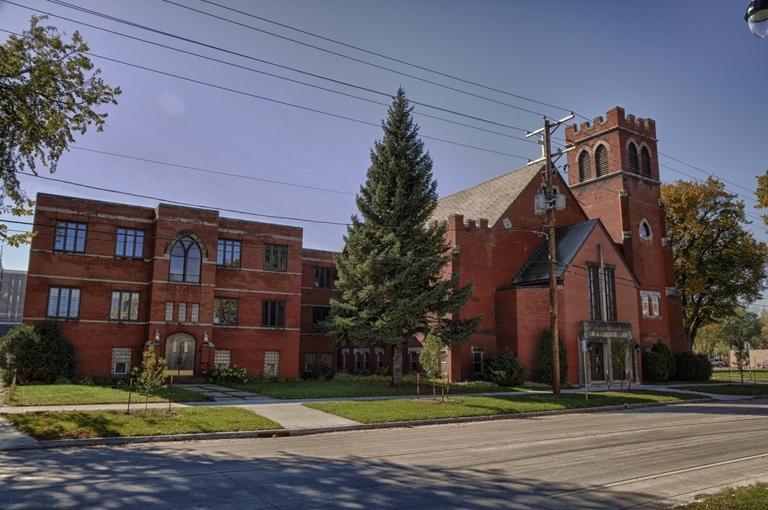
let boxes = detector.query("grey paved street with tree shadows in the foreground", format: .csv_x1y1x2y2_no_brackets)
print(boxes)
0,400,768,510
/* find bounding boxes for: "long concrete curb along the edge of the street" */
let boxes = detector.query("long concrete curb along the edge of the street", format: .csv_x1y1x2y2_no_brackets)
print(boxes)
0,397,728,453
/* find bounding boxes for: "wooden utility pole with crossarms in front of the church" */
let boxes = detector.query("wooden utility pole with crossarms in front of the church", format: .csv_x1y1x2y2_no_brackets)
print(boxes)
525,113,574,395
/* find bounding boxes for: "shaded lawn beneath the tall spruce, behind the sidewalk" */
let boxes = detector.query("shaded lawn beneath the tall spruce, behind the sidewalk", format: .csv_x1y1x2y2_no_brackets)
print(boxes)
223,377,526,399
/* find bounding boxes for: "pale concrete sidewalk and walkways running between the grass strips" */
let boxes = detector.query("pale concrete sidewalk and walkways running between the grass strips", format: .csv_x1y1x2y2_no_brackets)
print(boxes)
0,384,751,450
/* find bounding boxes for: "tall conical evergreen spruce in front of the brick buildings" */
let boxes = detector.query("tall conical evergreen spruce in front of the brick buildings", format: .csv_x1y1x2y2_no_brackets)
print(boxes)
324,88,482,386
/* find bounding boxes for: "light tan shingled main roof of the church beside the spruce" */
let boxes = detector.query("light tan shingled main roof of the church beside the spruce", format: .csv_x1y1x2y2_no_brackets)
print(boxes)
431,163,544,227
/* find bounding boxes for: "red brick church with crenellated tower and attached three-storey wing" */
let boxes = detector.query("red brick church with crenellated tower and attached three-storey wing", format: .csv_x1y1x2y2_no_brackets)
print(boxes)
24,107,684,383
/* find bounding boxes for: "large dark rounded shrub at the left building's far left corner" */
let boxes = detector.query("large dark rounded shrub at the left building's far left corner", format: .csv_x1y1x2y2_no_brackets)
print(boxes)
0,321,77,384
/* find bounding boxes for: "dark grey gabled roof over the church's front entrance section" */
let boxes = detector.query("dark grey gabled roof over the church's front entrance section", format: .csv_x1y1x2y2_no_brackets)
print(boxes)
512,220,598,285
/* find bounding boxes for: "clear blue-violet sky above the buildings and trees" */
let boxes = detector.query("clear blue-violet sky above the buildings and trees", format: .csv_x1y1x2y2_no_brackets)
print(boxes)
0,0,768,286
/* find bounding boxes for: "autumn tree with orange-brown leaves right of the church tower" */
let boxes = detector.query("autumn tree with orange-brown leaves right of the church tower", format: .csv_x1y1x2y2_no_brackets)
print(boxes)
661,177,768,350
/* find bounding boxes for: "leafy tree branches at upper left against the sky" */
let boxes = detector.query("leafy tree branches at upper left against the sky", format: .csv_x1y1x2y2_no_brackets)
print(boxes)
0,16,120,246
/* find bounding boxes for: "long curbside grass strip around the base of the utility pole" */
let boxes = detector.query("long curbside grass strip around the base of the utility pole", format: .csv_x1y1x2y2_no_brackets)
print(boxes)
304,391,699,423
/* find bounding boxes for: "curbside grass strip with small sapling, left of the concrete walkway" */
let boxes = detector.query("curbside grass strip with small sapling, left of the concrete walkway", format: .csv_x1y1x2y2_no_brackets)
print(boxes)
4,407,282,441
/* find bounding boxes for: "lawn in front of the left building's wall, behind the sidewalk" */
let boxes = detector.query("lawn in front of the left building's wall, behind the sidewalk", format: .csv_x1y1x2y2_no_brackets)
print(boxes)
6,384,213,406
